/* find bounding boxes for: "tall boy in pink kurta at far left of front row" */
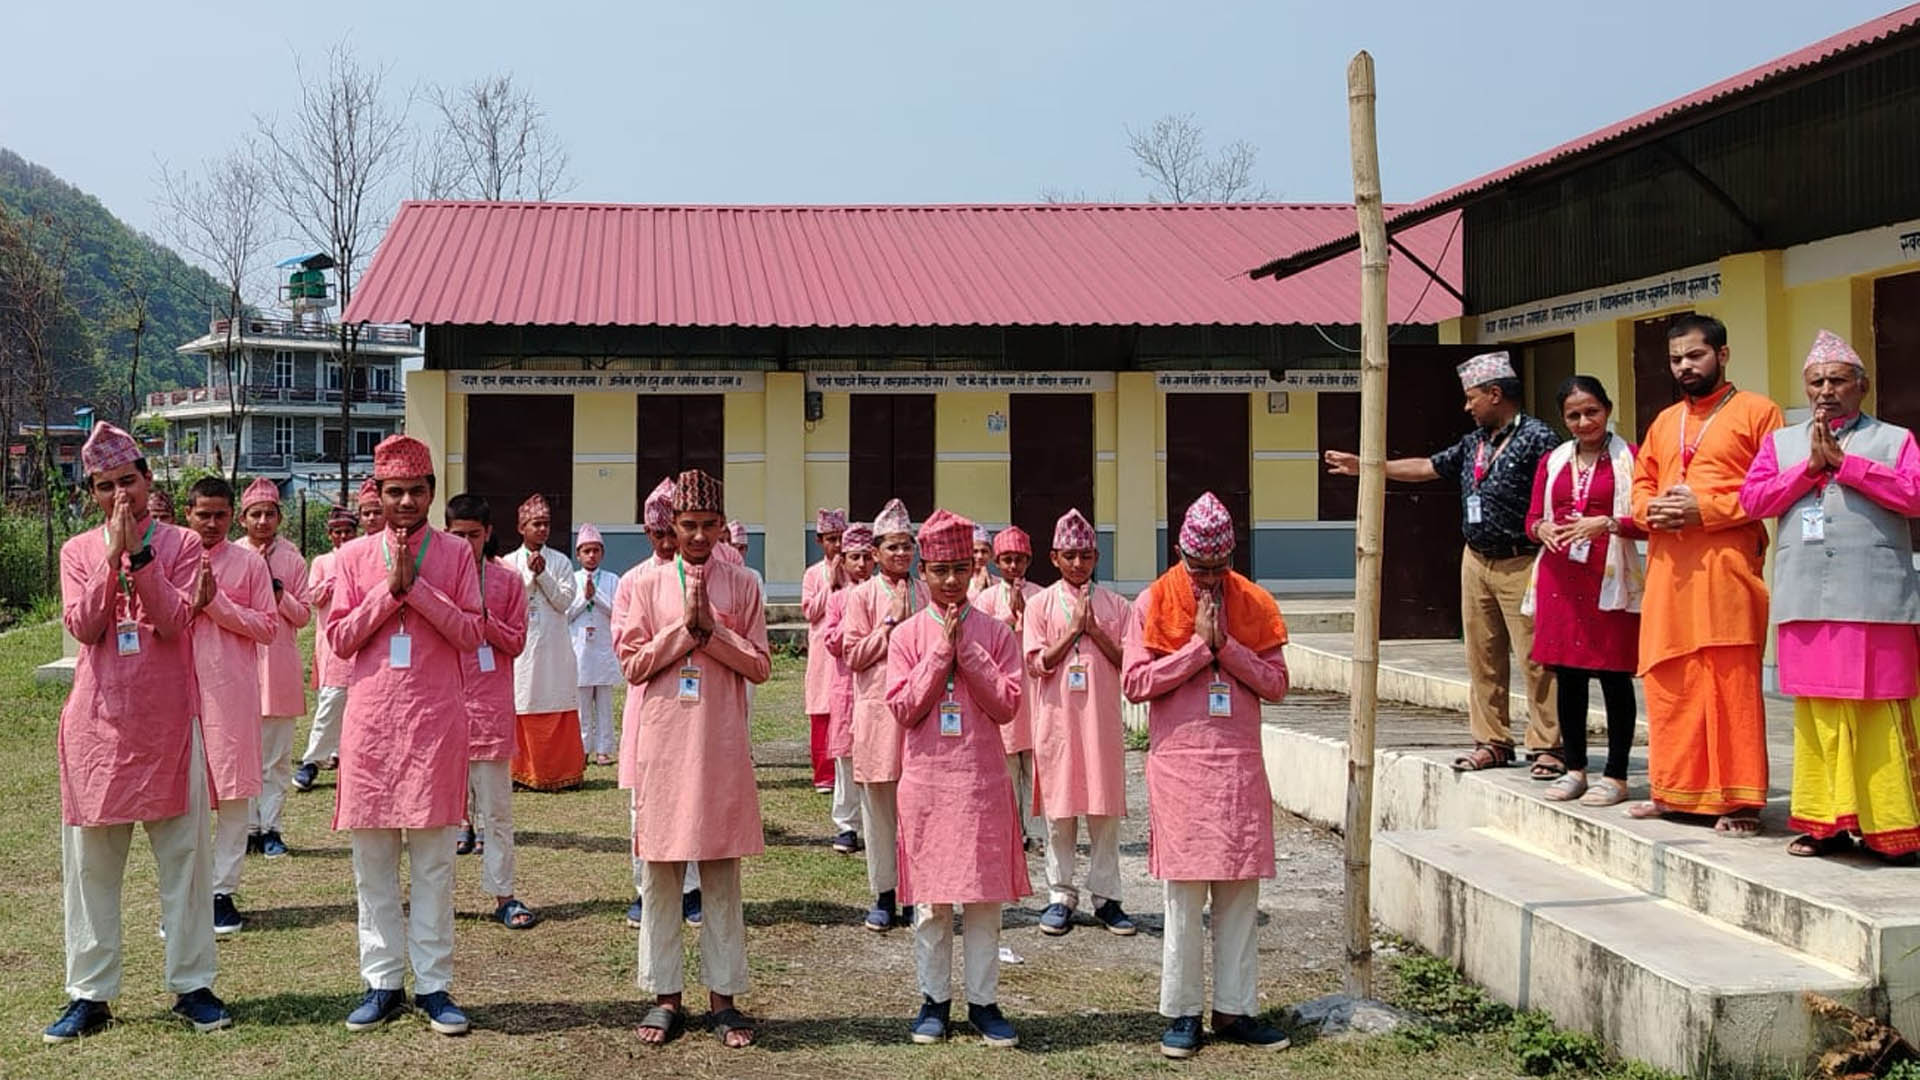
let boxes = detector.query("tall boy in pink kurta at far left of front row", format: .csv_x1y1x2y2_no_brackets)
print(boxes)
42,423,232,1043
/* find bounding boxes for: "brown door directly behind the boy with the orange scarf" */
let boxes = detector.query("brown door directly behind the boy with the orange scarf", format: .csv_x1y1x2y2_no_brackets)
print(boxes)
1159,394,1254,577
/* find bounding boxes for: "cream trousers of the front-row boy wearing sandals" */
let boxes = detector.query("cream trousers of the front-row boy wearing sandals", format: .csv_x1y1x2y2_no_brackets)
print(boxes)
637,859,747,997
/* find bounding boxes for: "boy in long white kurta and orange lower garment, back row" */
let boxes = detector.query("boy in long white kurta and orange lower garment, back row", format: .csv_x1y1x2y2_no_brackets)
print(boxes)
501,494,588,792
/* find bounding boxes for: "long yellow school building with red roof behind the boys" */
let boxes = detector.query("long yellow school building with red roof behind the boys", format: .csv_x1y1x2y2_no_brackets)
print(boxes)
346,202,1461,600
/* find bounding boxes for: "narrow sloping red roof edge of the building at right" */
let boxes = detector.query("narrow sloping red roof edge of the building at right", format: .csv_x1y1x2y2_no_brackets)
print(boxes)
1252,4,1920,277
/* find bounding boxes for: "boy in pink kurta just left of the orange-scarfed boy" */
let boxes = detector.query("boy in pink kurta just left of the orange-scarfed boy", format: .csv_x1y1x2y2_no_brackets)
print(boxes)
1023,509,1135,938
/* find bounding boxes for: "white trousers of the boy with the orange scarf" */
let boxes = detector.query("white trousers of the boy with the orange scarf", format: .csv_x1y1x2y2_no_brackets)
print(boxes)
1160,878,1260,1020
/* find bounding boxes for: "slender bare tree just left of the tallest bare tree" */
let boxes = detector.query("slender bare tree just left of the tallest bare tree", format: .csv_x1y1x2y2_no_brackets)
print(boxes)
159,138,269,482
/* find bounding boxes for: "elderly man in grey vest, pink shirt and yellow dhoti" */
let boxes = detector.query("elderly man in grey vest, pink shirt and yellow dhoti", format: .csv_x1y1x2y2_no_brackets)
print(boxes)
1740,331,1920,865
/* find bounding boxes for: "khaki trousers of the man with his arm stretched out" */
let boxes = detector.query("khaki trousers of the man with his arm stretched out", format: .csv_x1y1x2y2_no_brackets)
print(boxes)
1459,548,1561,749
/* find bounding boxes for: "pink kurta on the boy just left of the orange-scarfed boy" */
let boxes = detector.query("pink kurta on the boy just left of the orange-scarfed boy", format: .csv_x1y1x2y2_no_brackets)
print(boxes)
1023,580,1127,819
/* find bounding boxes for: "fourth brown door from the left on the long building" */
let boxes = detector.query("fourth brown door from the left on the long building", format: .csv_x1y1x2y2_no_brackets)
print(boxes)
1008,394,1092,584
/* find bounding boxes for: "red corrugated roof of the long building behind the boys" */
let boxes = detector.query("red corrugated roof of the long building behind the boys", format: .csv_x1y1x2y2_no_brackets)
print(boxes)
344,202,1459,327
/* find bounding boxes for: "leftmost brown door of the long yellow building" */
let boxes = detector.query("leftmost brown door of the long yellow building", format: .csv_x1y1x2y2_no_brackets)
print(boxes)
464,394,574,552
